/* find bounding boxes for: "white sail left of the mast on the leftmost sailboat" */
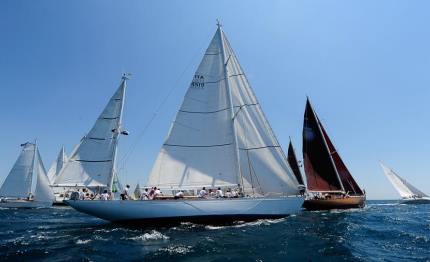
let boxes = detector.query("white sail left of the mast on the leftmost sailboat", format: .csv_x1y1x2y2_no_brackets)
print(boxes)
0,143,36,198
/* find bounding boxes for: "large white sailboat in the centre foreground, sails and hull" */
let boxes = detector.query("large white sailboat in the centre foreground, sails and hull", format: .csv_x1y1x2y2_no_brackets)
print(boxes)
67,24,303,225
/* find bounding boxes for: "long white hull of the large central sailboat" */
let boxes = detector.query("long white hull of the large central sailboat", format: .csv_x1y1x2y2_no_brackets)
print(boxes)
65,196,304,225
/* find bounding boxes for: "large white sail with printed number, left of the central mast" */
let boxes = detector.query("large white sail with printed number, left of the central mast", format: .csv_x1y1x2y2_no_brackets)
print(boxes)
147,27,237,188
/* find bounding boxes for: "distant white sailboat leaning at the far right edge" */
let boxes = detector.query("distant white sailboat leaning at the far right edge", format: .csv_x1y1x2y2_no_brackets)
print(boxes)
380,162,430,204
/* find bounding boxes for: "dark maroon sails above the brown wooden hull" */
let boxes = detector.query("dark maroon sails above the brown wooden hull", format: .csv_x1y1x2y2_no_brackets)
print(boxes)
303,99,364,195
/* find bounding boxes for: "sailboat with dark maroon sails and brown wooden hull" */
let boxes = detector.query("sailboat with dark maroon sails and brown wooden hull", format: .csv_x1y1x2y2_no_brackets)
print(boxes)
303,98,366,210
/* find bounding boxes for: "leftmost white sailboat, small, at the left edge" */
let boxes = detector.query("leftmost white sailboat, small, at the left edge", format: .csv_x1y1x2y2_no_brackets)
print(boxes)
0,142,54,208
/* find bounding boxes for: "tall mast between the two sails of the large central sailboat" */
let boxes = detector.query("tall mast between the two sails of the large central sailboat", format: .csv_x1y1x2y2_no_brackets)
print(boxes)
217,19,244,192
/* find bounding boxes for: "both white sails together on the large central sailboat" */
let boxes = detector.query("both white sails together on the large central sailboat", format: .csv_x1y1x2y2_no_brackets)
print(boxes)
147,26,298,195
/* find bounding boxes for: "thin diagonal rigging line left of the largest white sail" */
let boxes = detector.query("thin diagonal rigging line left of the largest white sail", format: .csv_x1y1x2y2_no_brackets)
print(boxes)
118,28,215,171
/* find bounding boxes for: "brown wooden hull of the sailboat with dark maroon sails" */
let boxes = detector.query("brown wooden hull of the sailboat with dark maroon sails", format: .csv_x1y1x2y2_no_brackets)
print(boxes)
303,196,366,210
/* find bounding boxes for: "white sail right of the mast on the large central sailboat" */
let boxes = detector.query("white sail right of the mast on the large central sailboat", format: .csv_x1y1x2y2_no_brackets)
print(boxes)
223,29,298,195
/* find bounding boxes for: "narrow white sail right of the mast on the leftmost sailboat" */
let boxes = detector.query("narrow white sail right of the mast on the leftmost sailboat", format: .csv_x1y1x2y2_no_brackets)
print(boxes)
33,149,55,203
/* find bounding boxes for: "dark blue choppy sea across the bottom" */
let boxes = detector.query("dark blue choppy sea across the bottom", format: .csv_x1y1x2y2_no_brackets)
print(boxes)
0,201,430,261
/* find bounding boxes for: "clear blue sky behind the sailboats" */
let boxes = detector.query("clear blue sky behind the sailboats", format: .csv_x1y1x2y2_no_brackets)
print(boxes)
0,0,430,199
